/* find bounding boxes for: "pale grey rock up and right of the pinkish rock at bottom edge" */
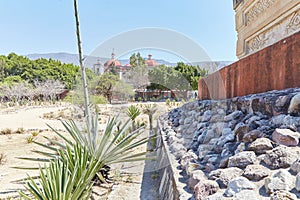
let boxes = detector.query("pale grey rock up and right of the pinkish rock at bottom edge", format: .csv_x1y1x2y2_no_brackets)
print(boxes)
209,167,243,188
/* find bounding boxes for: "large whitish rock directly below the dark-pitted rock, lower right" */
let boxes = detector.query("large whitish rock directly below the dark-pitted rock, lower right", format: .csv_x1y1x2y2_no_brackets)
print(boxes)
264,169,295,194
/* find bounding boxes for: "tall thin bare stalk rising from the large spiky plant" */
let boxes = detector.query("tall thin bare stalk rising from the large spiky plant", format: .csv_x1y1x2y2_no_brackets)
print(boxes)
74,0,91,125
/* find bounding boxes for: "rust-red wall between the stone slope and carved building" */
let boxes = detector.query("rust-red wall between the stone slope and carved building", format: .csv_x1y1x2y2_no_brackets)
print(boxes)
198,32,300,100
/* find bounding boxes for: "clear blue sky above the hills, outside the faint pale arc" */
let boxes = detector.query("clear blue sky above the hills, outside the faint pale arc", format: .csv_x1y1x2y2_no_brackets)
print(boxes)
0,0,236,61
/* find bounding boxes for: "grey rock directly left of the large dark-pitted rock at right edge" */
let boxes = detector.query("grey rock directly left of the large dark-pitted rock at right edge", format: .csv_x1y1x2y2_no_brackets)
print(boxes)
228,151,256,169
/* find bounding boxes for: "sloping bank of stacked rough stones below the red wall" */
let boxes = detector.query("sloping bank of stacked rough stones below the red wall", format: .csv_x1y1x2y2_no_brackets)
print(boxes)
163,88,300,200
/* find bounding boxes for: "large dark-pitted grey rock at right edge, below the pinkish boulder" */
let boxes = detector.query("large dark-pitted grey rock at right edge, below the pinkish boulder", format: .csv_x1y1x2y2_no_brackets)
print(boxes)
262,146,300,169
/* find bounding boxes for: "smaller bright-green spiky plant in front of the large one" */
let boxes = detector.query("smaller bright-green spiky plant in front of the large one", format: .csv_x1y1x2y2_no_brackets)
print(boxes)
19,144,100,200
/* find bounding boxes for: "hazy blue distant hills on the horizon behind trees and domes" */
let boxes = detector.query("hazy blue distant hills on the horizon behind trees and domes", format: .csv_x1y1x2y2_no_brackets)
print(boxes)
25,53,232,71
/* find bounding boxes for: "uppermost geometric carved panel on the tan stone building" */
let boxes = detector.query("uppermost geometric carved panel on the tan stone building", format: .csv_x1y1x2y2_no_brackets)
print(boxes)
245,0,276,25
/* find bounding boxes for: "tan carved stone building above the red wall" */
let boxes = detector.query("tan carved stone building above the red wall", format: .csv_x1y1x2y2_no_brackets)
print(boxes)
233,0,300,58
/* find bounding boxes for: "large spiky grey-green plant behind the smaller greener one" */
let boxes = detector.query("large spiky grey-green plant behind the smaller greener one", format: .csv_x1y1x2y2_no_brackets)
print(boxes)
17,116,150,195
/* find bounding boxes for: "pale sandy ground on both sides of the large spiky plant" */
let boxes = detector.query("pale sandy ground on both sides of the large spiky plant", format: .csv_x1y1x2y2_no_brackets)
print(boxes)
0,105,169,200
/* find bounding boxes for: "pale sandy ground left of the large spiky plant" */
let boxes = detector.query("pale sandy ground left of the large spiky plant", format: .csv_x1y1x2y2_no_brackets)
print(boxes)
0,107,69,198
